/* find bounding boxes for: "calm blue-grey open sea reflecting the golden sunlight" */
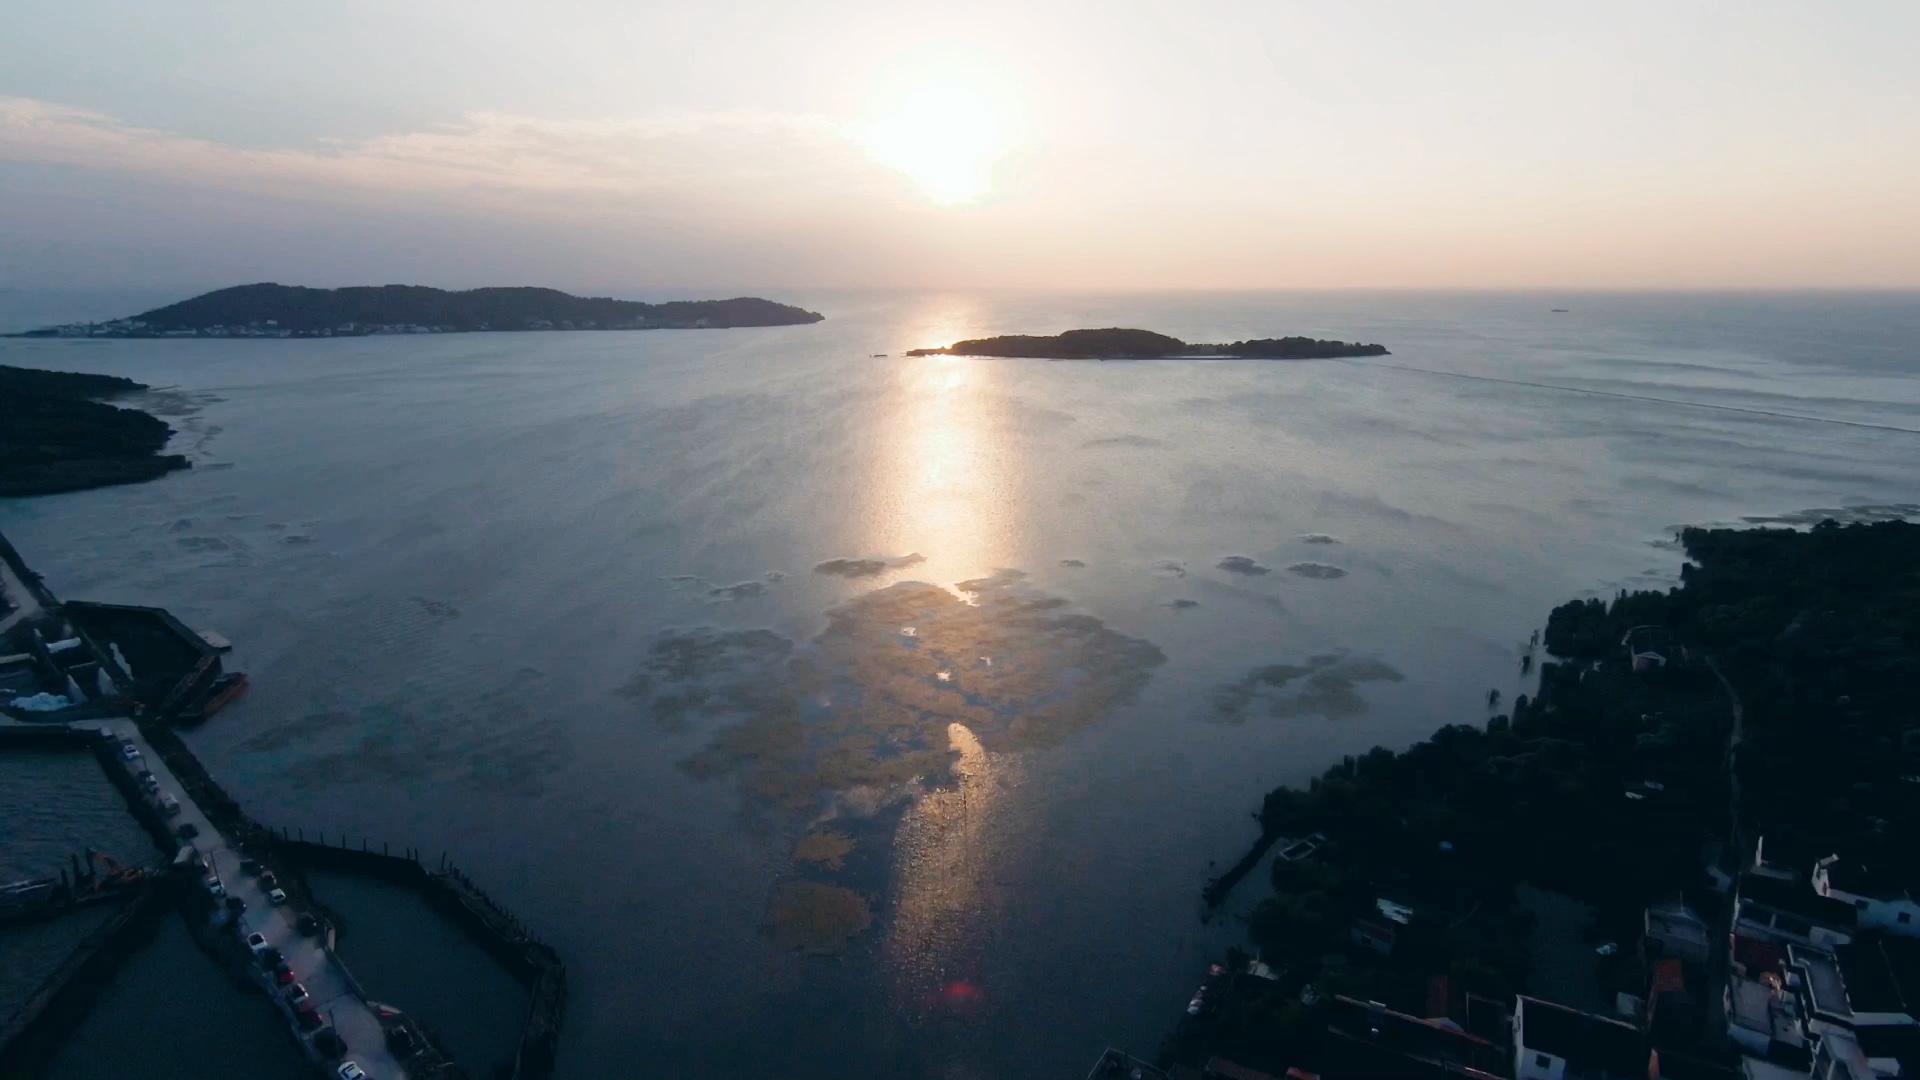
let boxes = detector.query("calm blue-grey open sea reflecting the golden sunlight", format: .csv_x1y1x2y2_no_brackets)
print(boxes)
0,294,1920,1078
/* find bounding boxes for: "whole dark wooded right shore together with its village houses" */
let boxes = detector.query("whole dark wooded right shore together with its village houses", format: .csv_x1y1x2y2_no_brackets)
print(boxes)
1160,521,1920,1080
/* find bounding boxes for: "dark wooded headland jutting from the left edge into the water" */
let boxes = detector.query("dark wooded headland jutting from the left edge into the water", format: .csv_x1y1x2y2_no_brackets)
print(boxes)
0,365,188,496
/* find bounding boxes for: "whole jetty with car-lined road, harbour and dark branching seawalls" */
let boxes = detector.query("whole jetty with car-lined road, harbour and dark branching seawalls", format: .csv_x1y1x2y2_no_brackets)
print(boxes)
0,536,566,1080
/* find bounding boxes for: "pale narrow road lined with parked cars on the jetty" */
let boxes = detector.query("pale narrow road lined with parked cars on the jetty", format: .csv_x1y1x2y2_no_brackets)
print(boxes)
88,721,405,1080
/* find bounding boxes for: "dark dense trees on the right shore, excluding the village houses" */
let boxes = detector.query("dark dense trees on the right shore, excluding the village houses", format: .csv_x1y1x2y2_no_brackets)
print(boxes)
1164,521,1920,1070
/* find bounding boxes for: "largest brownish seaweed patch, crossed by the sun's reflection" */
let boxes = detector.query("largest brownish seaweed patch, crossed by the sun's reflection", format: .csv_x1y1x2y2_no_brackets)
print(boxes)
622,571,1165,815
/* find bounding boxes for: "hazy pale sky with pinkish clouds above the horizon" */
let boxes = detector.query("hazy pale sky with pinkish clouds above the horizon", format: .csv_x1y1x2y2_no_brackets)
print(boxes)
0,0,1920,290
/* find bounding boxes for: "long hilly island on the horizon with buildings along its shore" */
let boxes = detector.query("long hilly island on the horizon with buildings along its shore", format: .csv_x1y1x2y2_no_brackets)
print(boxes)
21,282,826,338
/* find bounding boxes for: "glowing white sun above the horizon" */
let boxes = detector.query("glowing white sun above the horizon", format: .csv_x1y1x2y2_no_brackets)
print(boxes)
860,85,1010,206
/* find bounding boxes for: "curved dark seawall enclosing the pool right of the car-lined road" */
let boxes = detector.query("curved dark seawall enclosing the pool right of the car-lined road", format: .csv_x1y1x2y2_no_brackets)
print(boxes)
275,832,566,1080
